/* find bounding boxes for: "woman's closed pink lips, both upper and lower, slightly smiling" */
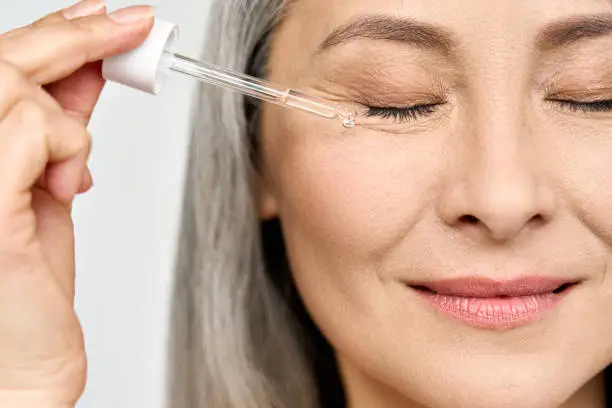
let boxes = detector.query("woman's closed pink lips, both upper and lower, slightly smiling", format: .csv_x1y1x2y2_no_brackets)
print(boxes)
408,277,578,329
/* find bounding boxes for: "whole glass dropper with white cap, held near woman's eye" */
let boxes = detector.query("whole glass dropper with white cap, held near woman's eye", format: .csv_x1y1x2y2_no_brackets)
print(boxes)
102,18,356,128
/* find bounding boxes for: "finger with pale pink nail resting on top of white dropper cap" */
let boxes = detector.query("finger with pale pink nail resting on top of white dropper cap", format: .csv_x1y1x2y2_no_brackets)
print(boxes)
0,6,154,85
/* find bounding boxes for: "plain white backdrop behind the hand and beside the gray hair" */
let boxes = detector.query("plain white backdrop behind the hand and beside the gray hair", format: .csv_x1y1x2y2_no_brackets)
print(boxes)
0,0,211,408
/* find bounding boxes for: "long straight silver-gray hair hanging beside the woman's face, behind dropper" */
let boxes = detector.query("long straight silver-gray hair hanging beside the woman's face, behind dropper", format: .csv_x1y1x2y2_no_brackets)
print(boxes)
169,0,317,408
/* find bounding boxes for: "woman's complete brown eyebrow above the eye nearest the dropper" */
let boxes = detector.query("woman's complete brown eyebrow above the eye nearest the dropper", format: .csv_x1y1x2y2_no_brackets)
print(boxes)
317,15,455,55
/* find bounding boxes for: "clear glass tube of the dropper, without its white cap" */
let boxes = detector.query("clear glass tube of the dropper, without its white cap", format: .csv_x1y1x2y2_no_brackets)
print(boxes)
164,51,356,128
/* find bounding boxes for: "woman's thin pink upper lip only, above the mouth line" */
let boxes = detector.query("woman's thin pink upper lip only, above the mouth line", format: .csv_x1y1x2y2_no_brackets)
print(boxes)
408,276,579,298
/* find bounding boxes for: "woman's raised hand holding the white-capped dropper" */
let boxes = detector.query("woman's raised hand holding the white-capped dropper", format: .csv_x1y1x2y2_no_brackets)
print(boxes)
0,0,153,408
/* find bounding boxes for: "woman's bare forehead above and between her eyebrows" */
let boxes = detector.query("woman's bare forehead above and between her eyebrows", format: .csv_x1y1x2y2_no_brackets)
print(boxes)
277,0,612,54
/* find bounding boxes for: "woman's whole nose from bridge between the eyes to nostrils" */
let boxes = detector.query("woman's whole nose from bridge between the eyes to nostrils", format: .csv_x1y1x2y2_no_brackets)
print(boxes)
441,77,551,241
